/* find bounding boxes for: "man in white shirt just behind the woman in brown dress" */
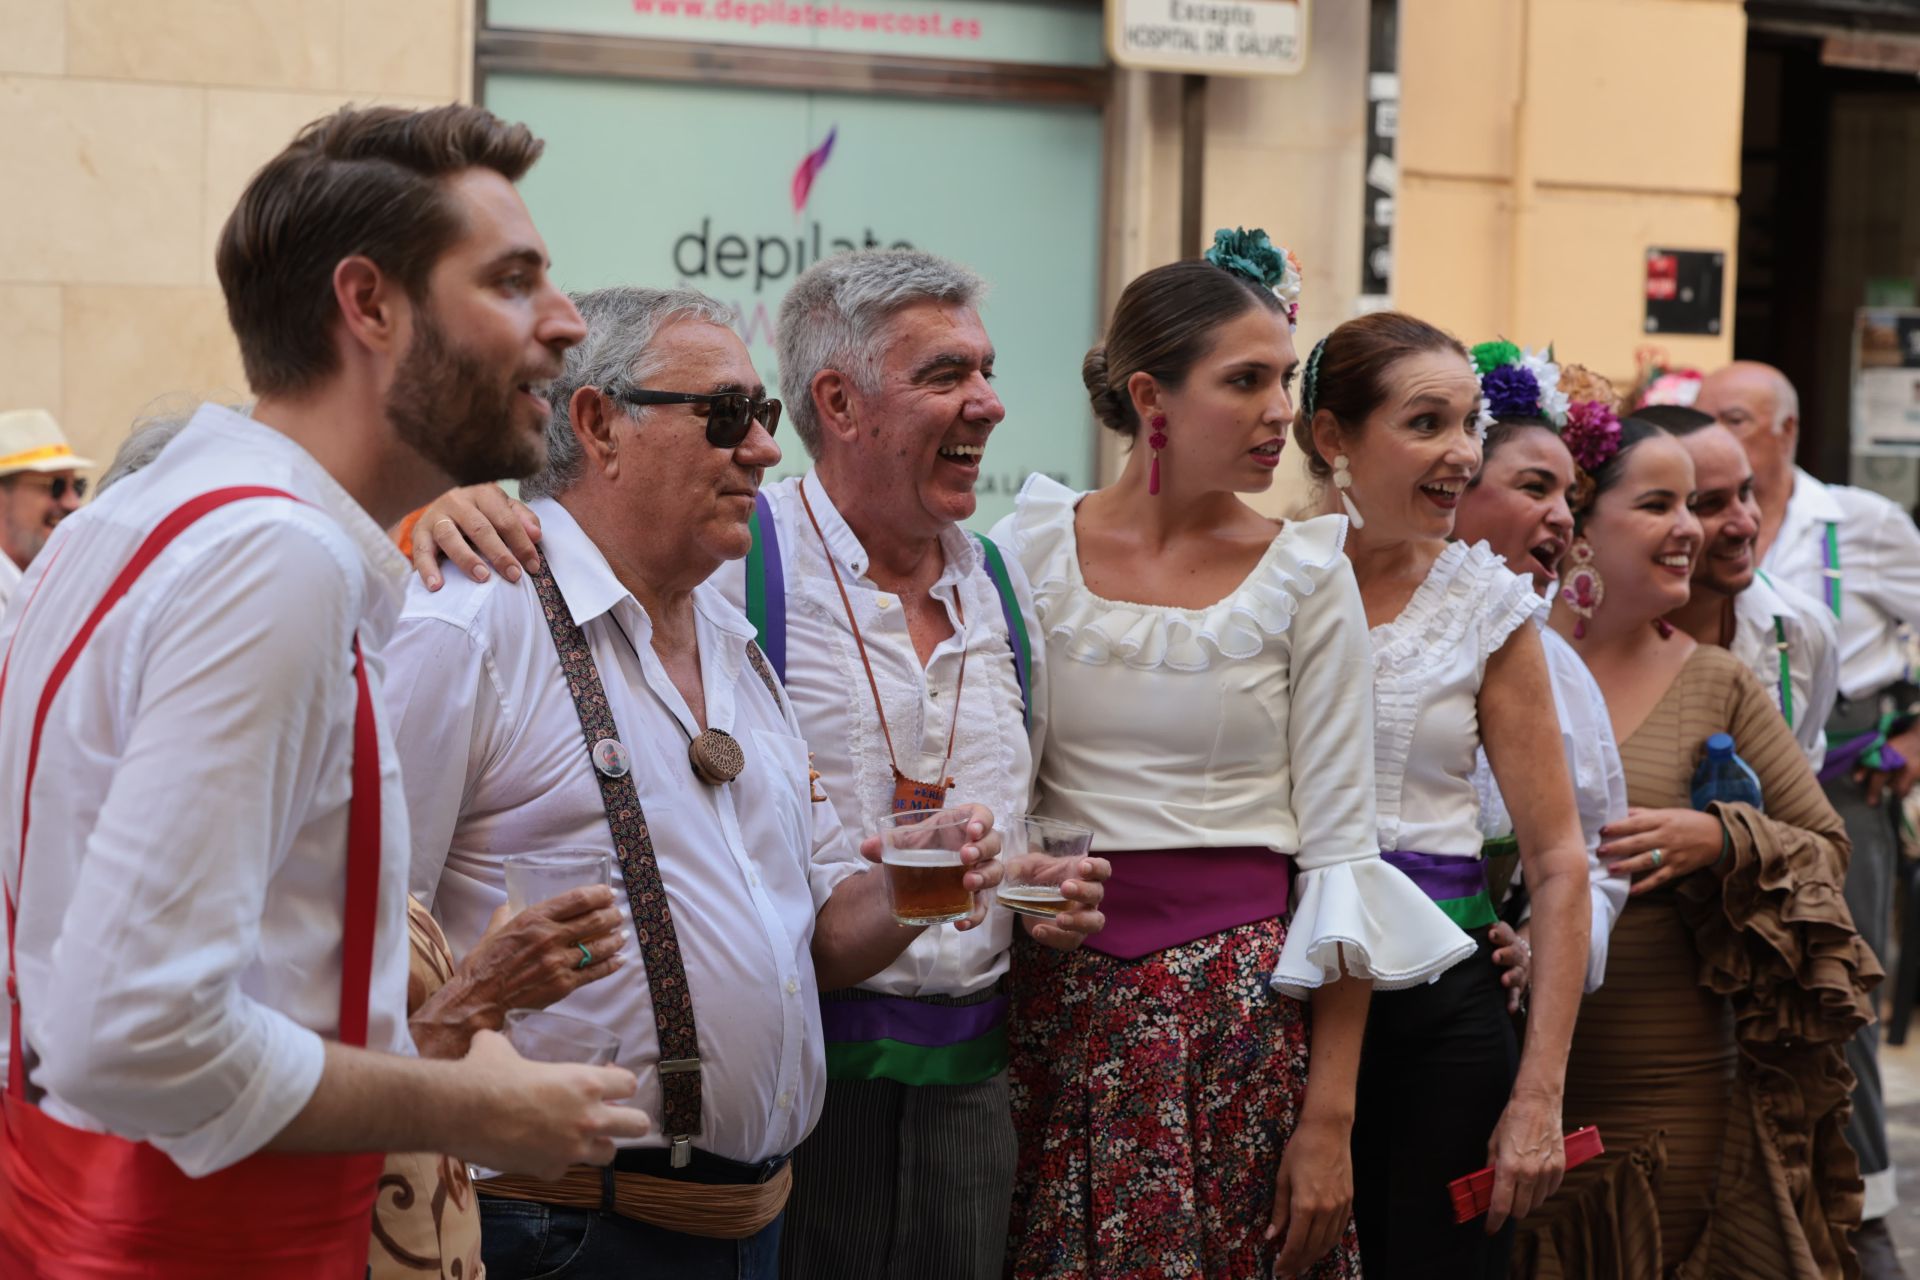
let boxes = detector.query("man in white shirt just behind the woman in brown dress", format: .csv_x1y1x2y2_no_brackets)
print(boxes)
1634,405,1839,773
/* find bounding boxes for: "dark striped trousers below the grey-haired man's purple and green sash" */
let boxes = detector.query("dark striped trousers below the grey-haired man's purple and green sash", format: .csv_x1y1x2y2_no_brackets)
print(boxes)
780,1071,1014,1280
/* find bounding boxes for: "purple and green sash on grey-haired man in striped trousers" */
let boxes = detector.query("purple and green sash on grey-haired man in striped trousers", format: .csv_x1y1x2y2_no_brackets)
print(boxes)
820,992,1008,1084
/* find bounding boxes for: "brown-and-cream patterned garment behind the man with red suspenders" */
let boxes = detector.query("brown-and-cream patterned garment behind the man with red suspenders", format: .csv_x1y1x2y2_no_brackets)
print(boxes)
367,898,486,1280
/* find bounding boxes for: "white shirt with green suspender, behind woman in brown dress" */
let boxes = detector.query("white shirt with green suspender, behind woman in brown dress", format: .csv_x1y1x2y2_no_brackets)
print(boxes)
1726,572,1839,773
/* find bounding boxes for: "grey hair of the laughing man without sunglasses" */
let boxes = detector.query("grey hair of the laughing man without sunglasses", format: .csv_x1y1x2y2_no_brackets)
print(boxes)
778,249,987,457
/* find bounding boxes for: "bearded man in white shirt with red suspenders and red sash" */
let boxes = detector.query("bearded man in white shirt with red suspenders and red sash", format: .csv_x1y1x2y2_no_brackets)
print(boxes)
0,107,647,1280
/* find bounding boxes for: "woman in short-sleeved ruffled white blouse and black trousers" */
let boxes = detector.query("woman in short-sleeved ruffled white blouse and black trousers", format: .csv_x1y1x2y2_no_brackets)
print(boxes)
1294,313,1588,1280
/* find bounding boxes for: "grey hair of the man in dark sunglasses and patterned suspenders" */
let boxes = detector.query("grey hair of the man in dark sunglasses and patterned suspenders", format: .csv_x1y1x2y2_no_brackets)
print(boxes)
520,284,733,497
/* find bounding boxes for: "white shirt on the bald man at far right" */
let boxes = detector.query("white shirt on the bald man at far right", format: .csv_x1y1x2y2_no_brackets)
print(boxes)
1761,468,1920,700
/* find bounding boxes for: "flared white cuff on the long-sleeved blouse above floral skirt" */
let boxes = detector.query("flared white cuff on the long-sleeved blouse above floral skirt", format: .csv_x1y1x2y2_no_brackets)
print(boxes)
1269,858,1475,1000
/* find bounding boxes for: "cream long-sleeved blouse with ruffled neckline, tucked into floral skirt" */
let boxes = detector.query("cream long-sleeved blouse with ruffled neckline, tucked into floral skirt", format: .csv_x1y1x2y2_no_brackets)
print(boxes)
995,474,1473,998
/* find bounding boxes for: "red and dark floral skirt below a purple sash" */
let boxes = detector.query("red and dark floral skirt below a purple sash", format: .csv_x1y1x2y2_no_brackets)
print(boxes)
1008,919,1359,1280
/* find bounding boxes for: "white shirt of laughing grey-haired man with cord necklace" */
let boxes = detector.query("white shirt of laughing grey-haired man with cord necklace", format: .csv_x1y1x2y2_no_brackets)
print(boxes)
714,472,1046,996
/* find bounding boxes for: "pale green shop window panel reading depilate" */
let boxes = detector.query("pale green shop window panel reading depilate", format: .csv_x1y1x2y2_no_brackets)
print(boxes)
486,75,1100,530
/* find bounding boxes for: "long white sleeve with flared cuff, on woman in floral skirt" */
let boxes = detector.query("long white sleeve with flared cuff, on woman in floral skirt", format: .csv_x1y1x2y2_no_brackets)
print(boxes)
1271,529,1475,1000
